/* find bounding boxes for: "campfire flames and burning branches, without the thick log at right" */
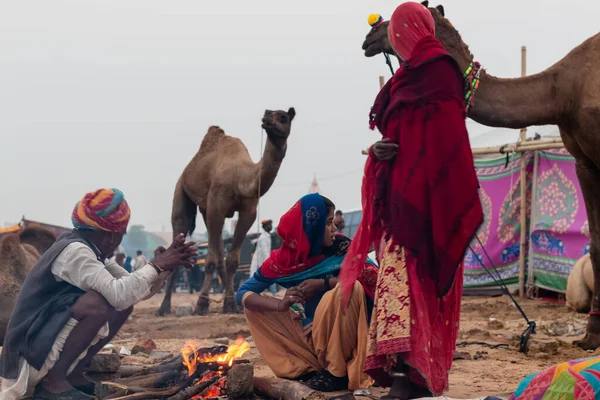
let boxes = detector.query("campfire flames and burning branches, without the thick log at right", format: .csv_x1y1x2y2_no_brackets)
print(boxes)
96,338,253,400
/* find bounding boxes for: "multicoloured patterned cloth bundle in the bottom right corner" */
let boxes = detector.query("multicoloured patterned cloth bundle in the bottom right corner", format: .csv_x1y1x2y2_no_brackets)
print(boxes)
511,357,600,400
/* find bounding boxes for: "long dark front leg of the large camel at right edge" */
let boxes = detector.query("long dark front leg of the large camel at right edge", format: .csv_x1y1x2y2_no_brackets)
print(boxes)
575,160,600,350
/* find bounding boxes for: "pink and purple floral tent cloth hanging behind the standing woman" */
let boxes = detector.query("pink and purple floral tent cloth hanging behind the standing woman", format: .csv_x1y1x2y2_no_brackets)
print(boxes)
465,150,589,292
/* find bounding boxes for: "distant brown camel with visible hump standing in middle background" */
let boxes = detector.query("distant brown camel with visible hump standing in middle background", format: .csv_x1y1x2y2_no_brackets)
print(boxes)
156,108,296,316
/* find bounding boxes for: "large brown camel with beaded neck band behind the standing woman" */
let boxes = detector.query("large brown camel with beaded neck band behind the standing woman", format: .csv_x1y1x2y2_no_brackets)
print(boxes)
362,2,600,350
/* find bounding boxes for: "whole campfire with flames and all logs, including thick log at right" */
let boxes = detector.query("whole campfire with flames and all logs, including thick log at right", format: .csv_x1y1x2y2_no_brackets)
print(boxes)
96,338,327,400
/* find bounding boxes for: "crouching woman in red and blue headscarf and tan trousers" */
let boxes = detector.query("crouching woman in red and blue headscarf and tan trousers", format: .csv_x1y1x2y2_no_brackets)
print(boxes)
236,193,377,391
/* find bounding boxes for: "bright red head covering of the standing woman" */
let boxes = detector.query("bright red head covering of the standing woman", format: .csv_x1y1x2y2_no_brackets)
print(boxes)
388,1,435,61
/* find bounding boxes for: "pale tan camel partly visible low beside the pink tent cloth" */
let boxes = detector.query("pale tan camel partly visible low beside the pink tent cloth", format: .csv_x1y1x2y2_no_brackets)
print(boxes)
567,253,594,313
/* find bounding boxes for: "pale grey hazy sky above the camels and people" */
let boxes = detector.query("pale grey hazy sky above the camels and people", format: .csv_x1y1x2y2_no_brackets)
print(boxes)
0,0,600,232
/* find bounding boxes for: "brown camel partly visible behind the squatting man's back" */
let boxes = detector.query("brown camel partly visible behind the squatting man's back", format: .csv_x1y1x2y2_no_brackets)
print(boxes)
0,228,56,345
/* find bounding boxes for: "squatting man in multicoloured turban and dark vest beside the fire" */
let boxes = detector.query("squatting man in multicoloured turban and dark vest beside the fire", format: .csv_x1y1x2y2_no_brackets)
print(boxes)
0,189,195,400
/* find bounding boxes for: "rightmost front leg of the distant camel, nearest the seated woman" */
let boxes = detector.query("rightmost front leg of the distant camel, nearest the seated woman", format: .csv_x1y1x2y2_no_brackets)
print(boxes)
223,207,256,313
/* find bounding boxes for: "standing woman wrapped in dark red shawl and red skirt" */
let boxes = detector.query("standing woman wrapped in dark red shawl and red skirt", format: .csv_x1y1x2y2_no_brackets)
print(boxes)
342,2,483,399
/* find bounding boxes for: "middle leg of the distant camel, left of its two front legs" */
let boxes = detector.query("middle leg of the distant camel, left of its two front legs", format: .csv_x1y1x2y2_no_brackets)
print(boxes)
194,209,225,315
